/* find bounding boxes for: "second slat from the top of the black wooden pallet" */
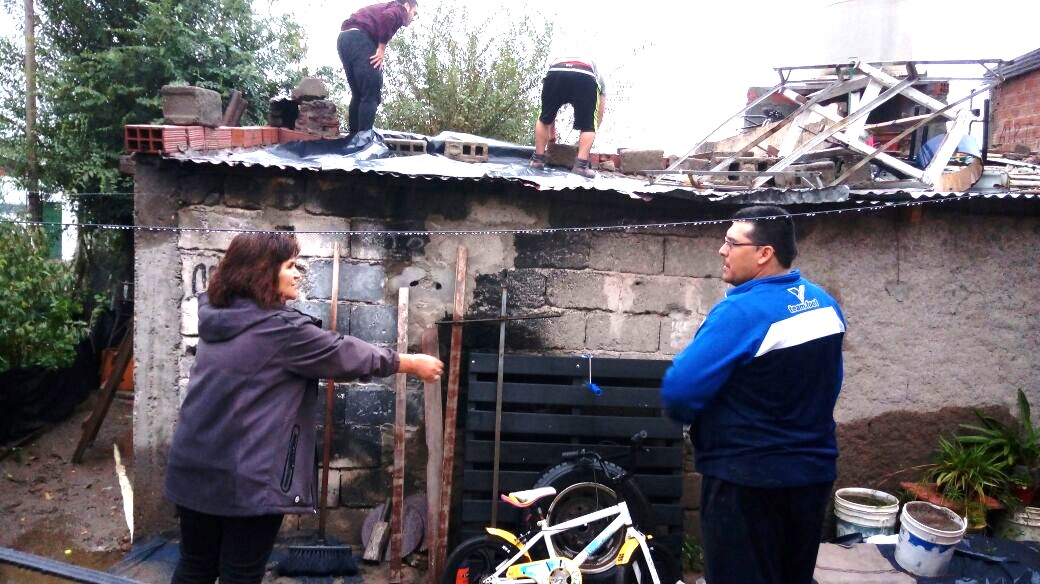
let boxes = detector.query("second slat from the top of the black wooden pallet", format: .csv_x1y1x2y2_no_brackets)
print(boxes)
468,381,660,410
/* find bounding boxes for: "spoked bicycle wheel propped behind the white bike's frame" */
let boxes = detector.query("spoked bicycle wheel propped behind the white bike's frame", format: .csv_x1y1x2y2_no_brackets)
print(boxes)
546,482,625,574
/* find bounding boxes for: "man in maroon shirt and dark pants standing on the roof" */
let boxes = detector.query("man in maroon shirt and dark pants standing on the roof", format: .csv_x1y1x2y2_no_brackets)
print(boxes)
336,0,419,134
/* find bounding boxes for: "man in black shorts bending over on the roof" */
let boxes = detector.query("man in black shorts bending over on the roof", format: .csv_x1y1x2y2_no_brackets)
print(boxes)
530,57,606,178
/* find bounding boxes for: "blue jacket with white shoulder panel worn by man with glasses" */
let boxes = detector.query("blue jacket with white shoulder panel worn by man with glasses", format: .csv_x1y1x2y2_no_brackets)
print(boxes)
661,270,846,487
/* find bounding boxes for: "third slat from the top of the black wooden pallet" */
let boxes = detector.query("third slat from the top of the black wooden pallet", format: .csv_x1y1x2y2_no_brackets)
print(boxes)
466,409,682,440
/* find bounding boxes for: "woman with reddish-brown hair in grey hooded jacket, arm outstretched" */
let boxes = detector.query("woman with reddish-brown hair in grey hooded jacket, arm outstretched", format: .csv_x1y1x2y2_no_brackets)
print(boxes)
165,233,444,584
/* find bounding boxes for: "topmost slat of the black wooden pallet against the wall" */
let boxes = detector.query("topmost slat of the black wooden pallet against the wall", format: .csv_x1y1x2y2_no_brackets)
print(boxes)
469,353,672,381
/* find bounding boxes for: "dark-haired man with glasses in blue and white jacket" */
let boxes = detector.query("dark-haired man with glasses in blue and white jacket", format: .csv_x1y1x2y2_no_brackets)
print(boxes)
661,206,846,584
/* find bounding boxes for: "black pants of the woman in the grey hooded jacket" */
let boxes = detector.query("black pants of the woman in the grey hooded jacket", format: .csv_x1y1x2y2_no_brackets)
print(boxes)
173,507,282,584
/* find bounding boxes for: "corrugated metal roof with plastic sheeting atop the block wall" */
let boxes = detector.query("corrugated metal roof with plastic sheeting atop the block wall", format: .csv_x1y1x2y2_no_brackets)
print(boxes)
164,133,1034,206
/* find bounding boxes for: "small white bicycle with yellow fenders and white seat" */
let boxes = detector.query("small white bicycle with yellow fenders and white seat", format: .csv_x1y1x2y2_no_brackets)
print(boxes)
441,486,681,584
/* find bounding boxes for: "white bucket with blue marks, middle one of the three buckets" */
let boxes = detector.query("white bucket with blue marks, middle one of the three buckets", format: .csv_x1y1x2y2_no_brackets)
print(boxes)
895,501,967,578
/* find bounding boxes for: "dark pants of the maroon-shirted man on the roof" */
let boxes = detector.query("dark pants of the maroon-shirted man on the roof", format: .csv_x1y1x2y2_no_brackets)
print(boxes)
336,30,383,134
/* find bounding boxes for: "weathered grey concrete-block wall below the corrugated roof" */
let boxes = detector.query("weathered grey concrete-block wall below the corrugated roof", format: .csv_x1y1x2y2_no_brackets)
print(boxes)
135,156,1040,542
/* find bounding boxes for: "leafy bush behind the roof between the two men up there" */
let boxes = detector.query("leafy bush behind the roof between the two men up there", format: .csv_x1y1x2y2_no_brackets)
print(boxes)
380,7,552,142
